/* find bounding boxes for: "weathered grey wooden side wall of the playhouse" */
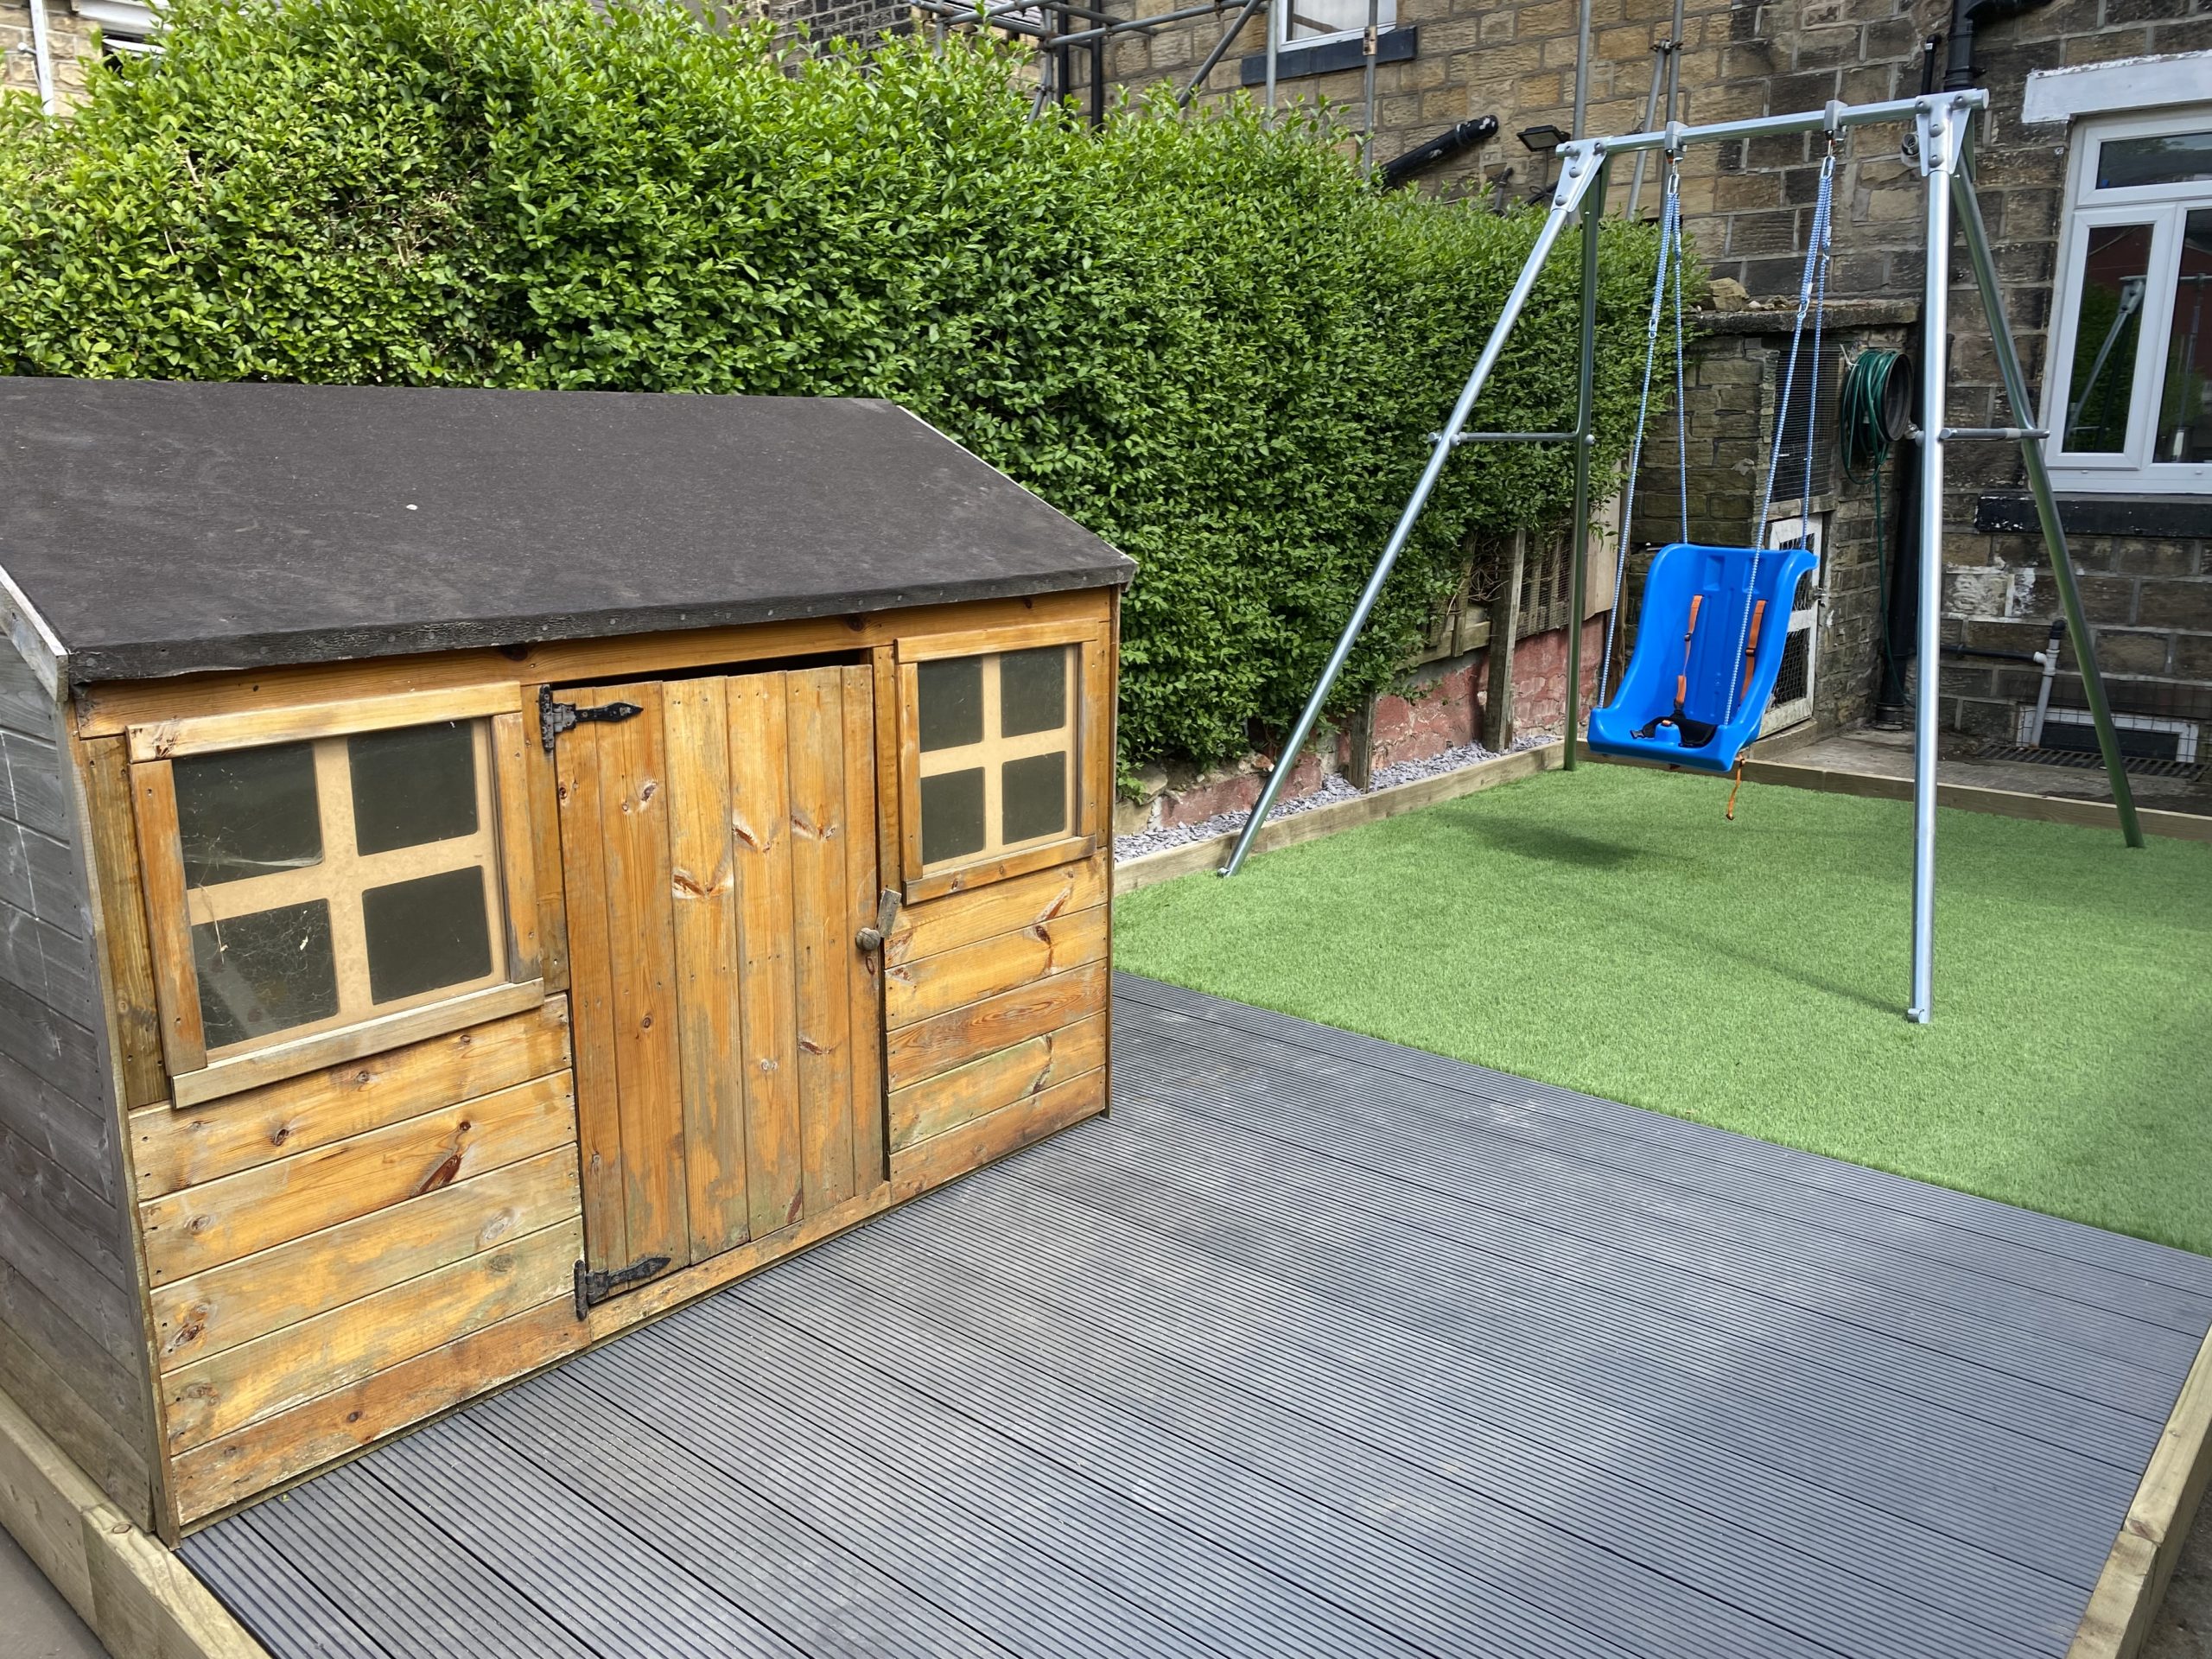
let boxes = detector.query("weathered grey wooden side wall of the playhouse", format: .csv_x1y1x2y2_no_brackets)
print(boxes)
0,651,155,1526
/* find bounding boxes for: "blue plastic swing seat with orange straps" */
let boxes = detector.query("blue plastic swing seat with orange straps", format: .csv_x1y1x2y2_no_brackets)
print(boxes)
1588,542,1818,772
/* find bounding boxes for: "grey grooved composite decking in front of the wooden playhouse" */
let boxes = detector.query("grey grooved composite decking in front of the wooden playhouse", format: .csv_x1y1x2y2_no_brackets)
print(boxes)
183,976,2212,1659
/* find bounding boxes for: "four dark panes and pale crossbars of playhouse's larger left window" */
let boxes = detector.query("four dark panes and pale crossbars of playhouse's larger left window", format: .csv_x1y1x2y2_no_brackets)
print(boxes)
173,721,506,1058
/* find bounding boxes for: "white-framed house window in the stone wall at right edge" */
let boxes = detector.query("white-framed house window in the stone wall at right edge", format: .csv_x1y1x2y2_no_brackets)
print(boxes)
2042,104,2212,495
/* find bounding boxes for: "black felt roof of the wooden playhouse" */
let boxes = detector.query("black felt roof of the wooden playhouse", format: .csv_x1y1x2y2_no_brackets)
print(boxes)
0,378,1133,683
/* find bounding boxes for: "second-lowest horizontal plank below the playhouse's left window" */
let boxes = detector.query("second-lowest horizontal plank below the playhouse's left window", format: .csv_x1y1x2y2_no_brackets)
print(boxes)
162,1221,584,1453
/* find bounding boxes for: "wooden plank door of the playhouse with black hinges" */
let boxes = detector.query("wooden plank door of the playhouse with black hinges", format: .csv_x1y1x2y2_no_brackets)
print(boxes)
549,668,885,1300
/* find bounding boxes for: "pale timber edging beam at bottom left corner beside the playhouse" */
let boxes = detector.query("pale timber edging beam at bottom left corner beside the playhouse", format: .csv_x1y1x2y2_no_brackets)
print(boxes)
0,1394,268,1659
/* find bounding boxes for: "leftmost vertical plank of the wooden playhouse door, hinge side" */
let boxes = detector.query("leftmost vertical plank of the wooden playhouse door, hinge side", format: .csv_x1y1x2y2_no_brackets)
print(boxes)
556,699,632,1272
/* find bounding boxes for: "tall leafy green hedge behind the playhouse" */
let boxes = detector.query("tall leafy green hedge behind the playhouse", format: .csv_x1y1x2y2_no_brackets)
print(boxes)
0,0,1652,763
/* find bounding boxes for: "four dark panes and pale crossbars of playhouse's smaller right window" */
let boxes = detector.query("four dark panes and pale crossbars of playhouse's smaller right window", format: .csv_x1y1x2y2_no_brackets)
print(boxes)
916,646,1079,872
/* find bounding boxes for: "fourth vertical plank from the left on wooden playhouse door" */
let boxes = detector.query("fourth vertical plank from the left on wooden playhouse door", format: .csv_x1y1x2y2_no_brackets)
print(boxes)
728,675,805,1236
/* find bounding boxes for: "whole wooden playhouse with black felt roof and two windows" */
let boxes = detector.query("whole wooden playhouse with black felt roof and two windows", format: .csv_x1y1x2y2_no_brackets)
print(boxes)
0,380,1133,1541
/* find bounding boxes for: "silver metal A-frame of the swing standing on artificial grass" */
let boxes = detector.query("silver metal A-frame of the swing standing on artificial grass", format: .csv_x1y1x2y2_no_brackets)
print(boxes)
1221,88,2144,1024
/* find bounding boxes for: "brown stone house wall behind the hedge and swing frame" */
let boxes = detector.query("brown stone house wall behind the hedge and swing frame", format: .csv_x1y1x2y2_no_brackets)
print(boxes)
1092,0,2212,739
